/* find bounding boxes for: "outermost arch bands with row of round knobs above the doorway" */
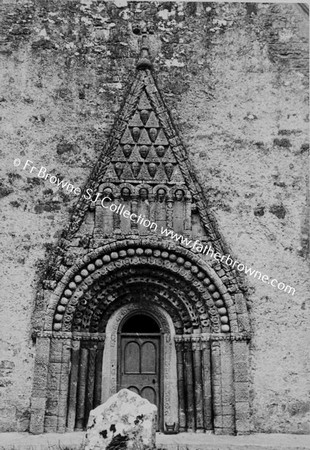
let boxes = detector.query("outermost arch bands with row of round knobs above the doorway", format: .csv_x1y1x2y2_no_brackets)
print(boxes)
44,239,249,335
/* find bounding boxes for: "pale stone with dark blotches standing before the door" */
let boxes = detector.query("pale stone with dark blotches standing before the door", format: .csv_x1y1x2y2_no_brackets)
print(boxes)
85,389,157,450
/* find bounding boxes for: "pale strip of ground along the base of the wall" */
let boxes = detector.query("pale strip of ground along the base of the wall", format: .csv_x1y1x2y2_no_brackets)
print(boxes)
0,432,310,450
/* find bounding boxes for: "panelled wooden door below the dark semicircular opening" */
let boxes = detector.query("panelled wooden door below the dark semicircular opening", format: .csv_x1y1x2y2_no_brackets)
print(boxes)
119,333,161,424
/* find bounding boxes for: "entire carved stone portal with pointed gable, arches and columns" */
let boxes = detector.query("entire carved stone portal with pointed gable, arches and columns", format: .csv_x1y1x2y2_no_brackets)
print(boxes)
30,36,250,434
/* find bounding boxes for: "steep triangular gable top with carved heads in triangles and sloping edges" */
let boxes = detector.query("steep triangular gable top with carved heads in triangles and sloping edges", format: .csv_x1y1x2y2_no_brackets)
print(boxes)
64,43,225,254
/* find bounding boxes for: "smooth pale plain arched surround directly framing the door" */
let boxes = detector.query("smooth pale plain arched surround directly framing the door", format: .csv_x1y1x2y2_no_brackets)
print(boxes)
102,303,178,424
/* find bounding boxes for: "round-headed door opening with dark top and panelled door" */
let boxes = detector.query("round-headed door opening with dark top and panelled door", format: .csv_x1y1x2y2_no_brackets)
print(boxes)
118,314,162,429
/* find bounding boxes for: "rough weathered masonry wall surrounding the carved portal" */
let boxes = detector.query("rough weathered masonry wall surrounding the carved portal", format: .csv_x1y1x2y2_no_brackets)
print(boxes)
0,0,310,433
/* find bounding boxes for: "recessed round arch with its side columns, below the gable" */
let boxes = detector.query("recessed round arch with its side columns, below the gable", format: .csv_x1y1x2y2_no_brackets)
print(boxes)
32,239,249,434
